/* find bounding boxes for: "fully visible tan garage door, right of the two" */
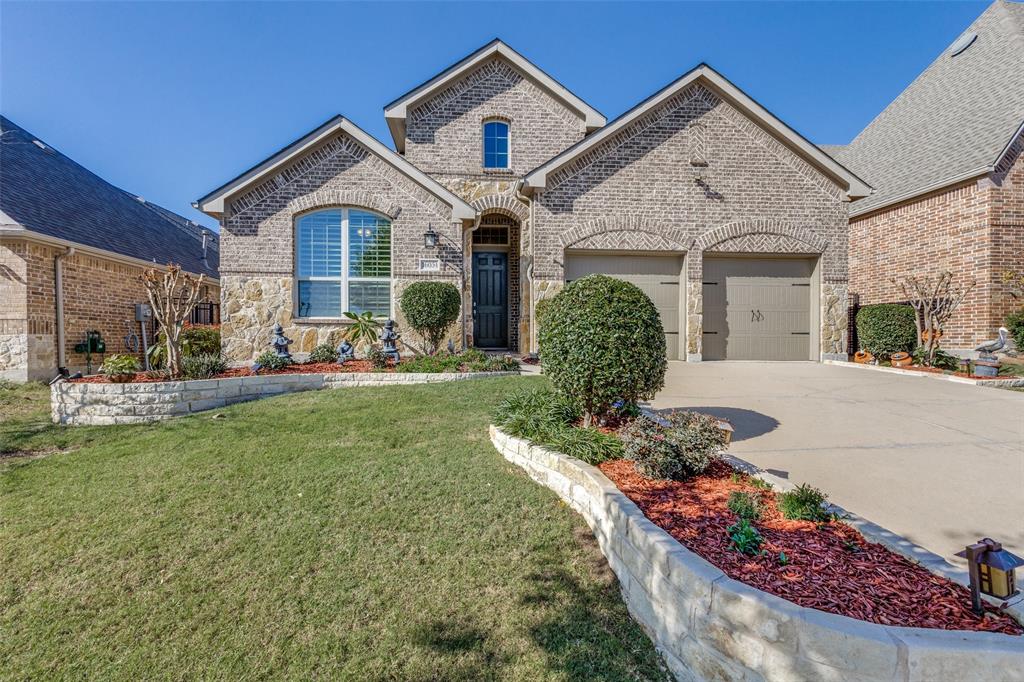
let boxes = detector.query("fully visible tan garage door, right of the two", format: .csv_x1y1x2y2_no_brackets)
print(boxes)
702,258,814,360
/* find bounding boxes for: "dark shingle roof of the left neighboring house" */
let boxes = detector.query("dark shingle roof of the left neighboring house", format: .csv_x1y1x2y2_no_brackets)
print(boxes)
0,117,219,278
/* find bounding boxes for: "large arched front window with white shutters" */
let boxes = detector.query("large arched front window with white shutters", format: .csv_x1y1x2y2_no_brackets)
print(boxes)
295,208,391,317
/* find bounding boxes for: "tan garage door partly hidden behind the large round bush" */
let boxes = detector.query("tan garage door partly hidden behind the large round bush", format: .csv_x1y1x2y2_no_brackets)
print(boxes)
565,254,682,359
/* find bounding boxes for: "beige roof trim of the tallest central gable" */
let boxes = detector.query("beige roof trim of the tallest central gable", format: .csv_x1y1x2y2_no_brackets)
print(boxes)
384,38,607,154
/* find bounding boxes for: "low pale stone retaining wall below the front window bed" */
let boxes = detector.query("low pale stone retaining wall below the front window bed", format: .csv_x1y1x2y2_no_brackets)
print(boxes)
50,372,518,426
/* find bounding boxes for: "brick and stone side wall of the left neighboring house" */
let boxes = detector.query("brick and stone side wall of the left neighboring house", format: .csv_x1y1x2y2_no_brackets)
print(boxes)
0,241,220,381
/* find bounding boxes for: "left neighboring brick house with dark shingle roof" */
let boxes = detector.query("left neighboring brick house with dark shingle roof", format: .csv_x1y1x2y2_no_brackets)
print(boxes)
0,117,220,381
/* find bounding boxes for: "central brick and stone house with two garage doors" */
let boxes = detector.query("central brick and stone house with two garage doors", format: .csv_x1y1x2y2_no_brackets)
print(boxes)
195,40,870,361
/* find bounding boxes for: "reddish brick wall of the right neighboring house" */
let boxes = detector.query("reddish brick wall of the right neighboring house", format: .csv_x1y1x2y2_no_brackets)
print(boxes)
850,129,1024,350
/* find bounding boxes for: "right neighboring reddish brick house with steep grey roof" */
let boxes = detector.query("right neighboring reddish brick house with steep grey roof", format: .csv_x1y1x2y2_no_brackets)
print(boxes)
822,0,1024,352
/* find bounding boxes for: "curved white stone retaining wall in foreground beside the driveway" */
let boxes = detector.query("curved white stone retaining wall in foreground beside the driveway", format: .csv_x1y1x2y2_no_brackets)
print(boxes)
490,426,1024,682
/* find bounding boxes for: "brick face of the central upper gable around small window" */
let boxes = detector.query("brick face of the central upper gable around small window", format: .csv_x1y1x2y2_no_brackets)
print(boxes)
406,57,585,177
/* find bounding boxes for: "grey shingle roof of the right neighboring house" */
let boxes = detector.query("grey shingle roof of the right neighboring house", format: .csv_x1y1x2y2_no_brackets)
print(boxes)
835,0,1024,215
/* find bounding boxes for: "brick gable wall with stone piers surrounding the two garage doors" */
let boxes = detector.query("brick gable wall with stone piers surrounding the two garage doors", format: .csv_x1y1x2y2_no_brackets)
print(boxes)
532,84,848,359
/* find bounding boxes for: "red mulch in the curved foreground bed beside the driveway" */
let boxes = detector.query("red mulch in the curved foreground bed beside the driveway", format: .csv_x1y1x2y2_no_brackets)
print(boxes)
600,460,1024,635
